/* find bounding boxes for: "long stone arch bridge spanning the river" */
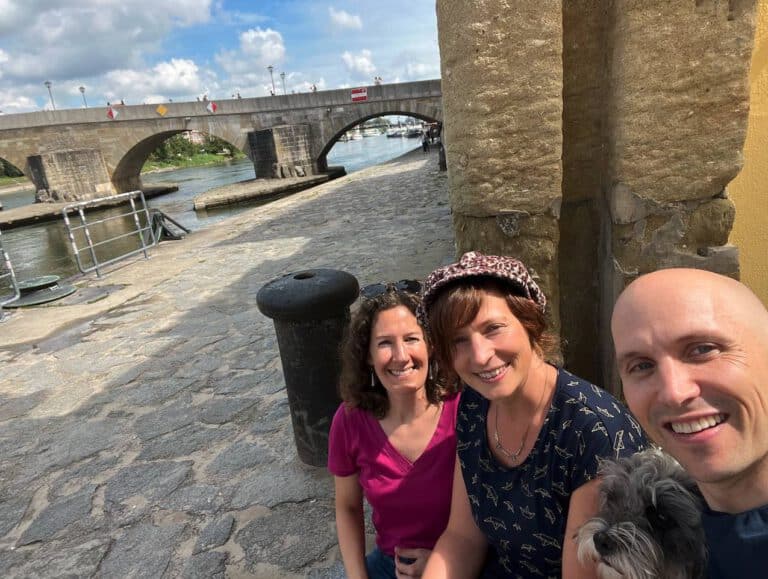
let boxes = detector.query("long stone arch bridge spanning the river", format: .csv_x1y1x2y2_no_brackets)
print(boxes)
0,80,443,200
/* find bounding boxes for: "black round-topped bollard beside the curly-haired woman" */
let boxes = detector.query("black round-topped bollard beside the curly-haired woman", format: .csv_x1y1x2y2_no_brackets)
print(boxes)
256,269,359,466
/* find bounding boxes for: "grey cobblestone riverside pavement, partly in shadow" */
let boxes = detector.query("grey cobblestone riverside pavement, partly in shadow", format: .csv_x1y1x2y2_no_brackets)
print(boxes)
0,151,453,579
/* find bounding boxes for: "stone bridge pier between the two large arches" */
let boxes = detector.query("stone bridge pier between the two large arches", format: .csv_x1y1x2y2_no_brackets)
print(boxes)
248,124,318,179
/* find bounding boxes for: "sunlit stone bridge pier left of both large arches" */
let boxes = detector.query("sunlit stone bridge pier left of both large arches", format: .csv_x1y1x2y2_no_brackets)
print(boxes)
27,149,115,202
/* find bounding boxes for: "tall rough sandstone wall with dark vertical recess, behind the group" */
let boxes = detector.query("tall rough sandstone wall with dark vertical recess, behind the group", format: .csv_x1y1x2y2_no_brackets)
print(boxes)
437,0,755,390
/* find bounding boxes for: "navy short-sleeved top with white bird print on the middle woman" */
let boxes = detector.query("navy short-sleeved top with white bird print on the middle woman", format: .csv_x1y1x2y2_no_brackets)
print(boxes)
456,370,647,578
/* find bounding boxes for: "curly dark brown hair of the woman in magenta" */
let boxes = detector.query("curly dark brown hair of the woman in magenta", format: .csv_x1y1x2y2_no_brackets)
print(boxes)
339,291,454,419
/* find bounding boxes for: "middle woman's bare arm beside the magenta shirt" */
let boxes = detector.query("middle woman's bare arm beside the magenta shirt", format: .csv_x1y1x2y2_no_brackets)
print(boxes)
422,458,488,579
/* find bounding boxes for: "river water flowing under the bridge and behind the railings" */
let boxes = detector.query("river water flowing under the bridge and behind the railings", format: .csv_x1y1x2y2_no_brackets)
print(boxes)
0,135,421,284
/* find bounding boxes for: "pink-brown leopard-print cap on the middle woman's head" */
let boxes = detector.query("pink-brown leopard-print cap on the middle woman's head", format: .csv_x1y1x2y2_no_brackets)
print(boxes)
417,251,547,324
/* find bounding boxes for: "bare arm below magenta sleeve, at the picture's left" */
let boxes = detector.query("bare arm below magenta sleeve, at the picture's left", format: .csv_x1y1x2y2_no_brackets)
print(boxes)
333,474,368,579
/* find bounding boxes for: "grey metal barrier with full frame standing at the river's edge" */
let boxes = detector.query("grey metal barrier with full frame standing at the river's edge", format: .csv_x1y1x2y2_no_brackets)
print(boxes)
61,191,158,277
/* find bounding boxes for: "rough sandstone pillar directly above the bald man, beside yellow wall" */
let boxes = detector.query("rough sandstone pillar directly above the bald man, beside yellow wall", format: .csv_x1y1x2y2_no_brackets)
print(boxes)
600,0,755,385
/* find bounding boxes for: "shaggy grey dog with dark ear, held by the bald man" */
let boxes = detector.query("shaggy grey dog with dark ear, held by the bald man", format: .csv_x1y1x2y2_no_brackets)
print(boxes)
576,449,707,579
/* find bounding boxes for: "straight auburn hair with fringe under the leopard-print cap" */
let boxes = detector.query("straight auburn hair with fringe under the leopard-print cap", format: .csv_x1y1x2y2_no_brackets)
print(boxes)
427,277,559,383
